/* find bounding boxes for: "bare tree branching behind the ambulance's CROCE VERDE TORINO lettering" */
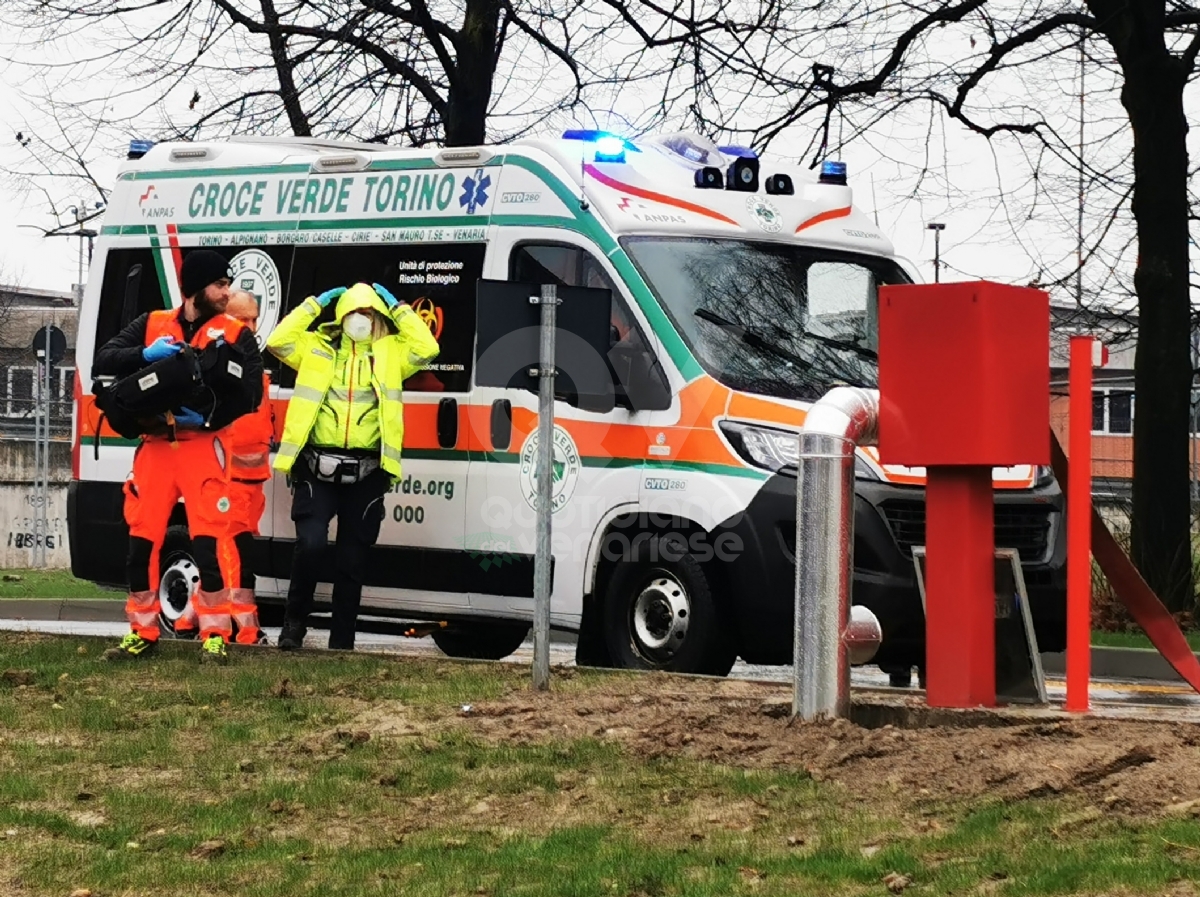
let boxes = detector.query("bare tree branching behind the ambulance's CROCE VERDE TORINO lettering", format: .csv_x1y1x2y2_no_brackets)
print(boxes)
0,0,606,145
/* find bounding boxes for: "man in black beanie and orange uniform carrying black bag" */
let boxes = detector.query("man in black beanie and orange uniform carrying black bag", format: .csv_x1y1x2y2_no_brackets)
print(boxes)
92,249,263,662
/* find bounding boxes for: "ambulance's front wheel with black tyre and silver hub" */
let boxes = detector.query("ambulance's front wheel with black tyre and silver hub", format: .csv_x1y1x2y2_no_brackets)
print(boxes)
604,536,737,676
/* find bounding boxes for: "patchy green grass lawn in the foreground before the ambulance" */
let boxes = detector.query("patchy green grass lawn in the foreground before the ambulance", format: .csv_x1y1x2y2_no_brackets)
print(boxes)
0,633,1200,897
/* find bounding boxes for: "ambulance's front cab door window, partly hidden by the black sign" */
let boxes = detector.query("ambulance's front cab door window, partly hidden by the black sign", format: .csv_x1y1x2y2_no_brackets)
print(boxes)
509,243,666,402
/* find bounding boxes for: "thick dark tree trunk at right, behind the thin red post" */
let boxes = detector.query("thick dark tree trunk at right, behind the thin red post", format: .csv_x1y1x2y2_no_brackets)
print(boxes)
1110,10,1195,610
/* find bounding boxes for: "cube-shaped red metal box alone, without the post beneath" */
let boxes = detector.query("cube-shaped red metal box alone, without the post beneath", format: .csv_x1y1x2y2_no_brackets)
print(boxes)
880,281,1050,466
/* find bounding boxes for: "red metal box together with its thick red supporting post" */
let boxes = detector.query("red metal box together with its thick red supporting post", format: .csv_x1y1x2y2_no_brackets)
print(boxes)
880,282,1050,708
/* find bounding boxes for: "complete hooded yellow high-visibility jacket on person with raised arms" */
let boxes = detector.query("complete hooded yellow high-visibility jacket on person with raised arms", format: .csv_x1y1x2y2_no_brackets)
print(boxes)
266,283,438,478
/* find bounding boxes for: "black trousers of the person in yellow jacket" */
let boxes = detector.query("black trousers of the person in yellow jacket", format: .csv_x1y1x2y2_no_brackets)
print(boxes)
284,457,391,650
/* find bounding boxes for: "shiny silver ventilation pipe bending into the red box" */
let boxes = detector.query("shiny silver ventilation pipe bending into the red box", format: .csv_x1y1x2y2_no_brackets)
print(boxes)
792,386,882,720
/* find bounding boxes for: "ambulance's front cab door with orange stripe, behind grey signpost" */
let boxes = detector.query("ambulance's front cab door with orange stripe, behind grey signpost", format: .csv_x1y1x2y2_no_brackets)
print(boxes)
467,229,667,626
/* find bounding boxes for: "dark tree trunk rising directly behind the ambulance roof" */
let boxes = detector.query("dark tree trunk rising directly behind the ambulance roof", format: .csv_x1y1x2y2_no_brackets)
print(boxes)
446,0,500,146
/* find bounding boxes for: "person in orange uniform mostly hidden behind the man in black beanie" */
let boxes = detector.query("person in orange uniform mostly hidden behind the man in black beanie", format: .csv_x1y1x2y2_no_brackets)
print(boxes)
217,290,275,645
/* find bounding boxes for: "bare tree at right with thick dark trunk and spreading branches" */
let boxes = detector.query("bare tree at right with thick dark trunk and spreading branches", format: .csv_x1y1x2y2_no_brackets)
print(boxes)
658,0,1200,609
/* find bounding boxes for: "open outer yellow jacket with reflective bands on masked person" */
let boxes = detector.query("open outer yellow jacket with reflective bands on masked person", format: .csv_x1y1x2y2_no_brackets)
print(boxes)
266,288,438,478
